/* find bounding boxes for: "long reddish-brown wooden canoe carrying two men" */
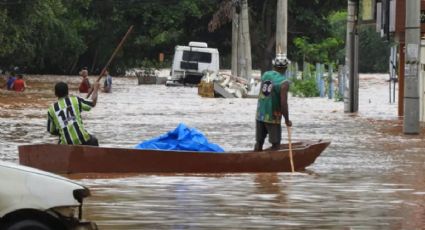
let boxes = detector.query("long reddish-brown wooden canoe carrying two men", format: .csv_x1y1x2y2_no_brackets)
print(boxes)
18,140,330,174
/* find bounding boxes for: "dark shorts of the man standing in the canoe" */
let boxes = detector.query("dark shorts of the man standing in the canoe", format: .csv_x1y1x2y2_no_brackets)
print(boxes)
255,121,282,145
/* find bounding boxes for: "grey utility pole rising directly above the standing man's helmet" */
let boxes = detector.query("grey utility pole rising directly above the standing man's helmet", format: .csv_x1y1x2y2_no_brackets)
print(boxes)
276,0,288,54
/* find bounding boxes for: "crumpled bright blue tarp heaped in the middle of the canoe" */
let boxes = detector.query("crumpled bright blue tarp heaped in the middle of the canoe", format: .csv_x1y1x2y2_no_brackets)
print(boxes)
135,123,224,152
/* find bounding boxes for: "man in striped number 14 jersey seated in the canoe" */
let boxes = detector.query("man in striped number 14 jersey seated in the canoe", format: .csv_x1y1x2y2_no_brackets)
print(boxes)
47,82,100,146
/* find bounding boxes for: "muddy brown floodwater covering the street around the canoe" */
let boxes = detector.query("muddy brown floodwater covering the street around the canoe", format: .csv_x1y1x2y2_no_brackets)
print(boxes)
0,75,425,229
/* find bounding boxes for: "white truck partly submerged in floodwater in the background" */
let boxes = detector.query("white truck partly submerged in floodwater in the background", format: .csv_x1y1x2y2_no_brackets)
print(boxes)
165,42,220,85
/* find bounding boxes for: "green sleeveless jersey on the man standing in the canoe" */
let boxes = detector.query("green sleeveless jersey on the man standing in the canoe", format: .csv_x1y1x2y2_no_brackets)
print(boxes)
256,71,287,124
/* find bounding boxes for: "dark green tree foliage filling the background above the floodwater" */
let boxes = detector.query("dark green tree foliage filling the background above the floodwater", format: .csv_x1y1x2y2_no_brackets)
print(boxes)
0,0,388,74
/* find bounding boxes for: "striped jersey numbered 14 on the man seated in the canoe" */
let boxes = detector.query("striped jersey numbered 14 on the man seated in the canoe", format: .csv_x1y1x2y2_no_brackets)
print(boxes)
47,96,93,145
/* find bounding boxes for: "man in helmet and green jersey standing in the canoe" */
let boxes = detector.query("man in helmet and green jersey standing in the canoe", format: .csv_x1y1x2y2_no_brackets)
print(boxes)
254,54,292,151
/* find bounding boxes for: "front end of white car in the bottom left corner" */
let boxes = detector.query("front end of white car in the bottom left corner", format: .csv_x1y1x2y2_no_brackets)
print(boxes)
0,161,97,230
